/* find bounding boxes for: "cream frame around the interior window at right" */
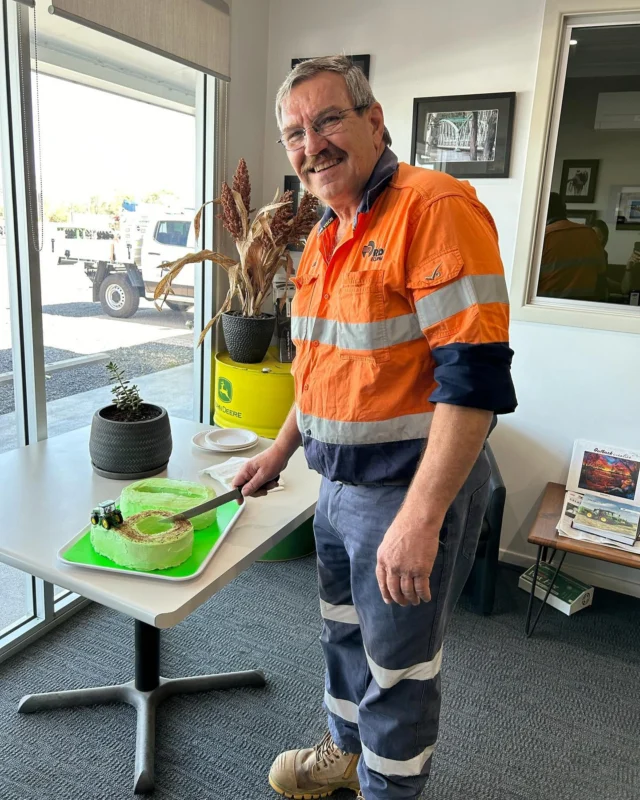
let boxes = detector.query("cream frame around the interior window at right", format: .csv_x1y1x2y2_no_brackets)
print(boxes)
510,0,640,333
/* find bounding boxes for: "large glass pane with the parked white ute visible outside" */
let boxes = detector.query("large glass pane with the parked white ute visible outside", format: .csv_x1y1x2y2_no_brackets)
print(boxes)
32,26,198,444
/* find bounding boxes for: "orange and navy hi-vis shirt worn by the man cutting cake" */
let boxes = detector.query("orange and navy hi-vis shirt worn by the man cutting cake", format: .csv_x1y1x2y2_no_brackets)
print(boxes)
292,148,516,484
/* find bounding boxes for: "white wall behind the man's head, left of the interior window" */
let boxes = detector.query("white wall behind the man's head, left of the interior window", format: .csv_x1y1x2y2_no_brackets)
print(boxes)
265,0,543,260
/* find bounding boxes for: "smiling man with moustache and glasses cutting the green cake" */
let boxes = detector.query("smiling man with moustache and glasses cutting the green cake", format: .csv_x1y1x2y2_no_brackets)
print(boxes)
235,56,516,800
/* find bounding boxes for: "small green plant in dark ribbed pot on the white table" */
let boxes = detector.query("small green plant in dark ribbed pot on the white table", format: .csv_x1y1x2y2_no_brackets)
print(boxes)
89,361,173,479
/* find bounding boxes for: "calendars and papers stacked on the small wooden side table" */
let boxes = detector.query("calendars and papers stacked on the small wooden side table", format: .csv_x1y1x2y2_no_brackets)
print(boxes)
558,439,640,555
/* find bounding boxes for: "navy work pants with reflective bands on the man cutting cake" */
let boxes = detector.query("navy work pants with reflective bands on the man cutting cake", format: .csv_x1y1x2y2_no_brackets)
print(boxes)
315,452,490,800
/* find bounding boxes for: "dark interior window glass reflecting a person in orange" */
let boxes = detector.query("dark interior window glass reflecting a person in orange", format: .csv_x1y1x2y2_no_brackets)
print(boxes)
536,25,640,306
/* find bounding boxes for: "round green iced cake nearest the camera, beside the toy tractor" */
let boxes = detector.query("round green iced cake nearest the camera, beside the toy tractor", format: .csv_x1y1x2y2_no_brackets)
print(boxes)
91,510,193,570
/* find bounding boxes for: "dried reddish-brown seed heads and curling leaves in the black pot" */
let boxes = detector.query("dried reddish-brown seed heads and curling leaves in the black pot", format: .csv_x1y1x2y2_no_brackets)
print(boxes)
154,158,318,345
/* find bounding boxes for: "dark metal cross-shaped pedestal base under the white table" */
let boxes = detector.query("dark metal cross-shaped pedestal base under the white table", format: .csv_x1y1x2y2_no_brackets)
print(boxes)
18,620,266,794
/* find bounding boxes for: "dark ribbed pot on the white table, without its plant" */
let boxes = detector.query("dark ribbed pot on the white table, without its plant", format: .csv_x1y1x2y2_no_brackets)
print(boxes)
89,403,173,480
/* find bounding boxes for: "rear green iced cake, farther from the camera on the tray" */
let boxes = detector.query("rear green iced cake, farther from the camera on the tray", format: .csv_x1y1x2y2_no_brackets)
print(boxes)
120,478,216,531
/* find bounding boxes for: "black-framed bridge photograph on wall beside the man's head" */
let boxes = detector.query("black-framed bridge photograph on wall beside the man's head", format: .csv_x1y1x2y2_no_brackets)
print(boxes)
411,92,516,178
